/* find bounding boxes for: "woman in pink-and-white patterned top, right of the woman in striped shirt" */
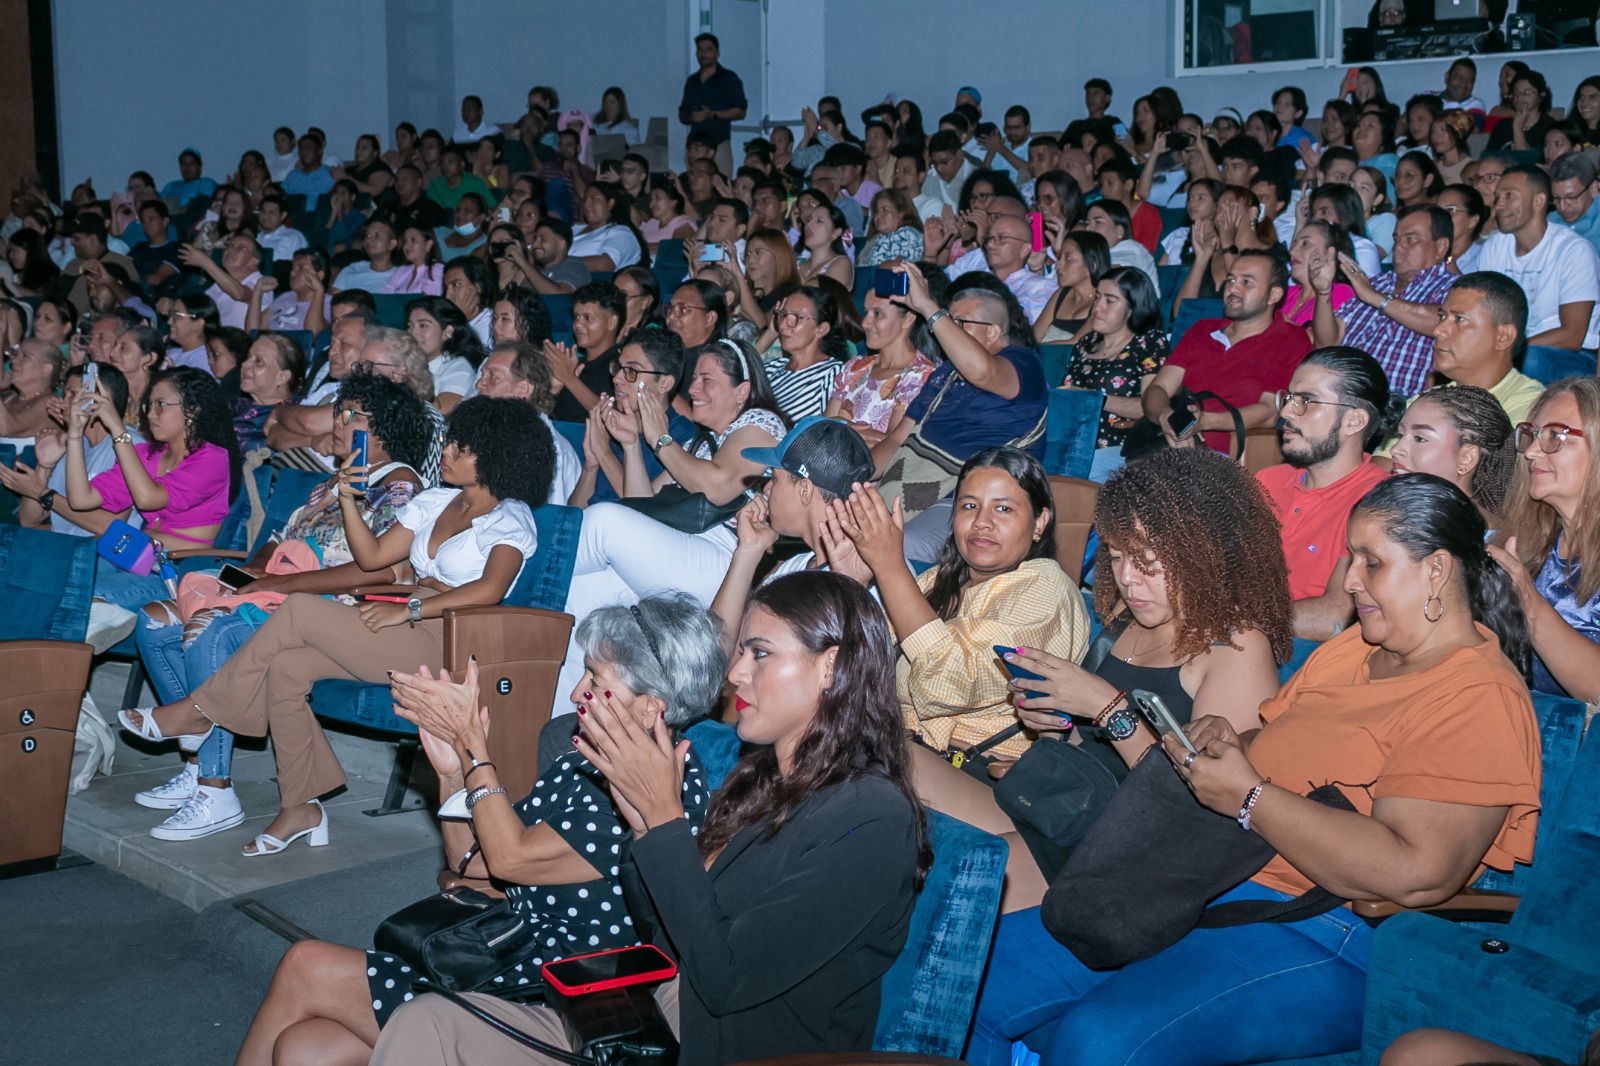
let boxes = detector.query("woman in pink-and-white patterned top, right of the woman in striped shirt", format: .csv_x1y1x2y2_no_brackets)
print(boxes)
822,284,939,445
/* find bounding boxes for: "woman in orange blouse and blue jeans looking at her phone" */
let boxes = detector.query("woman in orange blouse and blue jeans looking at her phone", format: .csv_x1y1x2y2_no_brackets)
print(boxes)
963,471,1542,1066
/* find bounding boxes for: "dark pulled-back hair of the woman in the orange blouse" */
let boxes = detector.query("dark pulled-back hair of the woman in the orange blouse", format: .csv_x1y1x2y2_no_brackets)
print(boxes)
1350,474,1533,677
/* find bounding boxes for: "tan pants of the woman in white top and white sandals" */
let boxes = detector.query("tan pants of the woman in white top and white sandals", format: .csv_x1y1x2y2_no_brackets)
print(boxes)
192,592,445,808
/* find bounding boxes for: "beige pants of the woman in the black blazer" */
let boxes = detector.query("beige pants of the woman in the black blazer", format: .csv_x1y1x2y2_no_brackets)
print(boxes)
371,980,678,1066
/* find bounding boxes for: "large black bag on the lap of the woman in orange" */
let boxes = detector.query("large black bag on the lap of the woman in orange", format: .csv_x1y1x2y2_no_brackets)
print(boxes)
1040,746,1355,970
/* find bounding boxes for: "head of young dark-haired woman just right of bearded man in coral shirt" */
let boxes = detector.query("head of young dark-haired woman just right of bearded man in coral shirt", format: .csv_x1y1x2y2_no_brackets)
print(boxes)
1389,386,1517,530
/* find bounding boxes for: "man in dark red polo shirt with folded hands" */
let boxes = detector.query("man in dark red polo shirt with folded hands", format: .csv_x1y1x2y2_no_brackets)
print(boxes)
1142,250,1310,455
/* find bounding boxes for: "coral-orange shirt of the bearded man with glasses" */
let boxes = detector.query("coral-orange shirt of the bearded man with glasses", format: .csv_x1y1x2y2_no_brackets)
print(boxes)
1256,455,1389,600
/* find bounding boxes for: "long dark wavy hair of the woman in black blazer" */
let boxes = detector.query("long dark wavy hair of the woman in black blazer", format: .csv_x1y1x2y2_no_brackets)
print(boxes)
699,570,933,890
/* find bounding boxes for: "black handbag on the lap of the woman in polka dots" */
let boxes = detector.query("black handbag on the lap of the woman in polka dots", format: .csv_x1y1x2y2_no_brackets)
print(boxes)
373,888,542,996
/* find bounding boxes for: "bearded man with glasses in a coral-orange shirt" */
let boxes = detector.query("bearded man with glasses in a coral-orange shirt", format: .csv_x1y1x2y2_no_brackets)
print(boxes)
1256,347,1402,640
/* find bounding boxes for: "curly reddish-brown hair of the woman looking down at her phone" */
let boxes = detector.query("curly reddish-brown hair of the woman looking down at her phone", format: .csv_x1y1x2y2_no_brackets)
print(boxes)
1094,448,1294,663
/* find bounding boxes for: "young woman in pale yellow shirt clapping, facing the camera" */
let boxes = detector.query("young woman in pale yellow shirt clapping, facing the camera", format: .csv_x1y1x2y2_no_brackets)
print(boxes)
832,448,1090,906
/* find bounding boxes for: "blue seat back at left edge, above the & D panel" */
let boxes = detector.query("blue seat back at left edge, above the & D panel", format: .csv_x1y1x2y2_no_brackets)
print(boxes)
0,525,98,640
